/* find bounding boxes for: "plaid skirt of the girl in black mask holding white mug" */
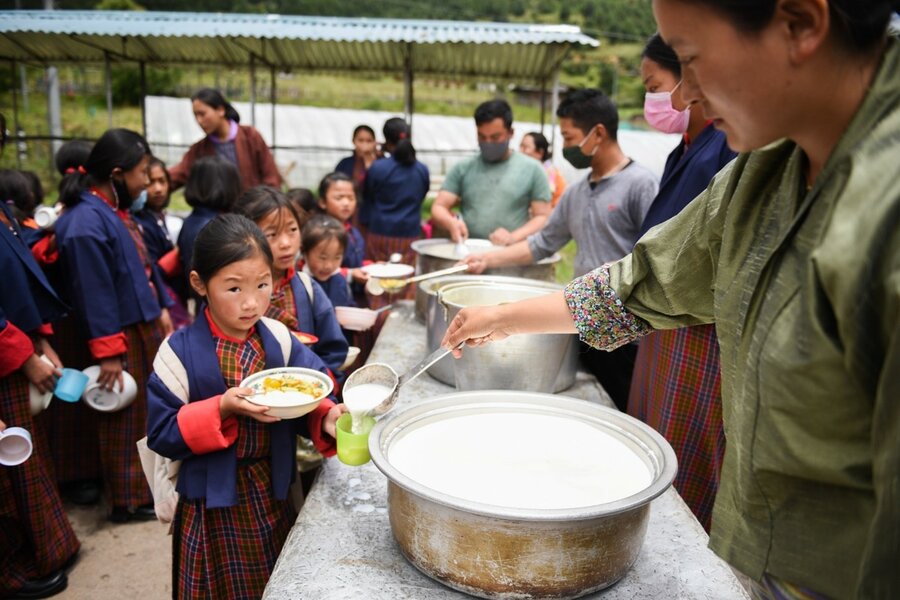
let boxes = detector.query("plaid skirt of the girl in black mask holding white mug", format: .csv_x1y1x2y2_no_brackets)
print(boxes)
97,322,163,509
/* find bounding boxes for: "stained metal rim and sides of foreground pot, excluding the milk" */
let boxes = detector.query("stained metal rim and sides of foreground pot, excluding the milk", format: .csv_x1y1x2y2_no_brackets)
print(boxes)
369,391,677,600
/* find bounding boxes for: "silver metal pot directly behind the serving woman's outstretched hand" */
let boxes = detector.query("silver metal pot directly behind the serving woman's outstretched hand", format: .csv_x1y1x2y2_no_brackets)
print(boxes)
437,284,578,393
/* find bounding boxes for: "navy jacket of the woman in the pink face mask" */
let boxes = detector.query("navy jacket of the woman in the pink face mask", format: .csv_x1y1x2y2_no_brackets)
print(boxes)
640,124,737,235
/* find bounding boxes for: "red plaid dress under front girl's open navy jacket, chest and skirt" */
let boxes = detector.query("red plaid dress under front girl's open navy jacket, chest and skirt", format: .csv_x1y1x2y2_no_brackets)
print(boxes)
172,333,297,599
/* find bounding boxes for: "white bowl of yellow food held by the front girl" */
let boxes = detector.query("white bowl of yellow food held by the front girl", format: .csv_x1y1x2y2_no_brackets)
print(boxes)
241,367,334,419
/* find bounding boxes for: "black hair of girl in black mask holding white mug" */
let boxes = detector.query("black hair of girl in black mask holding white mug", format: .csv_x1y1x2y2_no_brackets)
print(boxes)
57,129,150,207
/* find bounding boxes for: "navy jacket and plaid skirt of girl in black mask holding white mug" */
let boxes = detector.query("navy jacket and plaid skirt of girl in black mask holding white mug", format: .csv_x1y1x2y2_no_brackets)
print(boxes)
56,190,164,510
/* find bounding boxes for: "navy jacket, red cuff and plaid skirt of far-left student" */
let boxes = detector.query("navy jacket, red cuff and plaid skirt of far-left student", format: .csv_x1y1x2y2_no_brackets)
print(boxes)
0,205,80,597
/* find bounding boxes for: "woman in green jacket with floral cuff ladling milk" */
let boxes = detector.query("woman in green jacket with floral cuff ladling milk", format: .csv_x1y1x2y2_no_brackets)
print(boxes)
443,0,900,598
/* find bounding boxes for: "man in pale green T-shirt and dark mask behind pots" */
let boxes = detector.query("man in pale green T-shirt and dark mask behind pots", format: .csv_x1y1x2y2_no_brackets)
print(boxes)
431,100,551,246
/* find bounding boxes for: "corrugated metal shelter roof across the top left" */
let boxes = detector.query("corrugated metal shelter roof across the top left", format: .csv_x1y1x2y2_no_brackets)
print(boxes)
0,10,599,80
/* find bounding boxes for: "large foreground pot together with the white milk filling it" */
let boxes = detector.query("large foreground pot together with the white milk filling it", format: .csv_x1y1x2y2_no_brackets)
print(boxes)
369,391,677,599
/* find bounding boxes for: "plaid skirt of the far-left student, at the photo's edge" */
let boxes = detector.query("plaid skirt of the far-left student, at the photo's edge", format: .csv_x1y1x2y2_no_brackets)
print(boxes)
0,372,80,597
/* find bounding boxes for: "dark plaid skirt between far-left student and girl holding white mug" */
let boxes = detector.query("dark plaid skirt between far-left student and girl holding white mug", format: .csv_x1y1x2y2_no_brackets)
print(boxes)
37,316,101,484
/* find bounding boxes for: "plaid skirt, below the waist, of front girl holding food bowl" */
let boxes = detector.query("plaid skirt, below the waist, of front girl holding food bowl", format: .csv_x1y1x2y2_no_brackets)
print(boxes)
172,458,297,600
